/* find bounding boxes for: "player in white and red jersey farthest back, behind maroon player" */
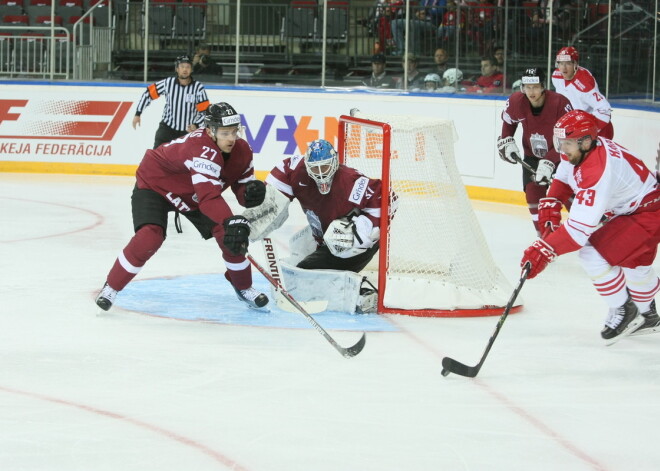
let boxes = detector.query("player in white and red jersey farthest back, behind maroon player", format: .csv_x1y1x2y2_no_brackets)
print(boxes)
552,46,614,139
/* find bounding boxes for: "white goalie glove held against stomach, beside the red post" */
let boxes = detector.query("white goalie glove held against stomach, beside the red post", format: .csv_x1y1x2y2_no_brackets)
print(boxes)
323,215,380,258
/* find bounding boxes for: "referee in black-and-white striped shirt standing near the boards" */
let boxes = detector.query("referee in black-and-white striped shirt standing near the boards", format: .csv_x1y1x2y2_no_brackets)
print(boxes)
133,56,209,149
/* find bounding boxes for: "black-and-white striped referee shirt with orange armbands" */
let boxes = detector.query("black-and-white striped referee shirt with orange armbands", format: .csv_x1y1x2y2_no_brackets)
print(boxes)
135,77,209,131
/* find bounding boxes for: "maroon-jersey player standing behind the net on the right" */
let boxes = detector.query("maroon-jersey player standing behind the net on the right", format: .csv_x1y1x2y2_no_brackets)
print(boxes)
497,68,573,235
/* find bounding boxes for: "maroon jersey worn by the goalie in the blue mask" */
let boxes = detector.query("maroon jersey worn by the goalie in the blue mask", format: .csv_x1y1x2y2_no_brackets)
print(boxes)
266,155,382,243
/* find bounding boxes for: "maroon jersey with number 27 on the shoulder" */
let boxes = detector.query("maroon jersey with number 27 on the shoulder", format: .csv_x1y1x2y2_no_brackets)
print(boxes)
137,129,254,224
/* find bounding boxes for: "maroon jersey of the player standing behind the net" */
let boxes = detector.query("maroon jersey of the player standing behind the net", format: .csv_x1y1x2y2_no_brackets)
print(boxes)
502,90,573,165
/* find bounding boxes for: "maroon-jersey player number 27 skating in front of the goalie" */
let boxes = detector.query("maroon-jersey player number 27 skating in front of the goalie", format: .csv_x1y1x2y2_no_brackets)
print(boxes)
96,103,268,311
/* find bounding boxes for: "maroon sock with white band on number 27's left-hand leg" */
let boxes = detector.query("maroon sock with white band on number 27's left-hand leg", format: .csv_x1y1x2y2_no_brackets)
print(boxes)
107,224,165,291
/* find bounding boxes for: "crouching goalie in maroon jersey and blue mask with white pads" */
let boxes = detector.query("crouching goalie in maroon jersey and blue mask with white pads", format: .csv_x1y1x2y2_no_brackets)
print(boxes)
243,139,381,313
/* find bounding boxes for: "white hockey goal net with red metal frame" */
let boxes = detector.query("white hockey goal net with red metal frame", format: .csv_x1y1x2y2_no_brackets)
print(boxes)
339,114,513,316
